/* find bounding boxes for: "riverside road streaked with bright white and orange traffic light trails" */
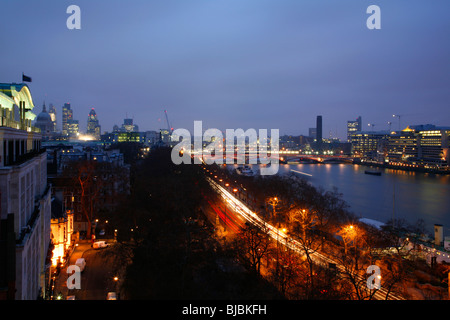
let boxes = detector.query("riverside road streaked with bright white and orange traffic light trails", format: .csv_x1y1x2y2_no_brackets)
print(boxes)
207,177,404,300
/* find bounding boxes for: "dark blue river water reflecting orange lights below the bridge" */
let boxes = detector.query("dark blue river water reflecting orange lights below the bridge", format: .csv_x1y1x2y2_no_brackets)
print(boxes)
232,164,450,236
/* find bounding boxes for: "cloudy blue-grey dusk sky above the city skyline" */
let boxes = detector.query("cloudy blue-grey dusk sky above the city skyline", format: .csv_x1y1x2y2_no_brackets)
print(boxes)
0,0,450,139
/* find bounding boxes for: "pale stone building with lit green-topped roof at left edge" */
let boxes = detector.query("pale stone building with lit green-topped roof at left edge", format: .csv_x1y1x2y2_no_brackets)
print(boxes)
0,83,52,300
